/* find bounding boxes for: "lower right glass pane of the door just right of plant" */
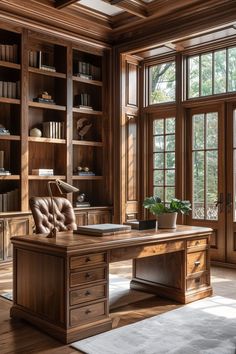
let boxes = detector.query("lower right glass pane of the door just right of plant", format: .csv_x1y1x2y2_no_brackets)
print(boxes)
206,150,218,220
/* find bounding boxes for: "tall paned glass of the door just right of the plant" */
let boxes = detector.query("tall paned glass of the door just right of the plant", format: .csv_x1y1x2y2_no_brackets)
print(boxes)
192,112,218,220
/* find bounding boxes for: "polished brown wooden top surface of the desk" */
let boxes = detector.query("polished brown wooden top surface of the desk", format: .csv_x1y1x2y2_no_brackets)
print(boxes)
11,225,212,253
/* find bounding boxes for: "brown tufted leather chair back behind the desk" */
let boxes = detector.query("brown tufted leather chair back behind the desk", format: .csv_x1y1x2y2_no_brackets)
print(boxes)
29,197,77,234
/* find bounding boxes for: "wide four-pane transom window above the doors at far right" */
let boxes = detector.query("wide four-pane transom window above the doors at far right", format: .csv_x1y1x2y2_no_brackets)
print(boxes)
187,47,236,98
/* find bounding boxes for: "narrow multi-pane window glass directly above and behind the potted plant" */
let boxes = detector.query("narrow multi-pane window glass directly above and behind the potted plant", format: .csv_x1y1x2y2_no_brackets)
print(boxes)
153,118,175,203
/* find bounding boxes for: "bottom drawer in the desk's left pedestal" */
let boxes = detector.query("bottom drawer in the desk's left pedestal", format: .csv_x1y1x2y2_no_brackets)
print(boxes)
70,301,106,326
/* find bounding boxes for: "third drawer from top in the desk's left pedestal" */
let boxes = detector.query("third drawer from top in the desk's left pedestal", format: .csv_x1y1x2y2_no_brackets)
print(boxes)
70,284,106,306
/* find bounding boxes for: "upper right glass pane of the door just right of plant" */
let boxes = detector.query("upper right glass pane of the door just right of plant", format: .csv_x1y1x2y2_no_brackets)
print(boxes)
206,112,218,149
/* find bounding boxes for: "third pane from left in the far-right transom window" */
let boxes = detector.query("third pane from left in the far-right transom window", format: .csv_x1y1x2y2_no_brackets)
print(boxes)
214,49,226,93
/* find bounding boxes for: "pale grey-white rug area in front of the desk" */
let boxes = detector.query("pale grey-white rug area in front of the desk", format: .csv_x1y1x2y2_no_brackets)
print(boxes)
72,296,236,354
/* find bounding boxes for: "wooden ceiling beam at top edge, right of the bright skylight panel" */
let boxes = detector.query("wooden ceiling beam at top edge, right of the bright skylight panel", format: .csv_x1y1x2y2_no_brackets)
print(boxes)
108,0,148,18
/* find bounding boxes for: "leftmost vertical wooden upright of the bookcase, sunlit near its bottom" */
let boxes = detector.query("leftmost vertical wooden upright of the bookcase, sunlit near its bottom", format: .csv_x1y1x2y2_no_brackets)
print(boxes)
21,30,29,211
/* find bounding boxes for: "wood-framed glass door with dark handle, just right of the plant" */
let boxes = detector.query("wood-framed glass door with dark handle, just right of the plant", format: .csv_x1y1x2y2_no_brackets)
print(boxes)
186,106,227,262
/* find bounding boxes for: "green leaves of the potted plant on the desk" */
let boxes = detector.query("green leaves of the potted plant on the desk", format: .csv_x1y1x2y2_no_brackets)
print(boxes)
143,196,192,215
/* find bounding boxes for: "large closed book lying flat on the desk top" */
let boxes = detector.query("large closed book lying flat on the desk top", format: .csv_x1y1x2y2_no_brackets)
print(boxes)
74,224,131,236
